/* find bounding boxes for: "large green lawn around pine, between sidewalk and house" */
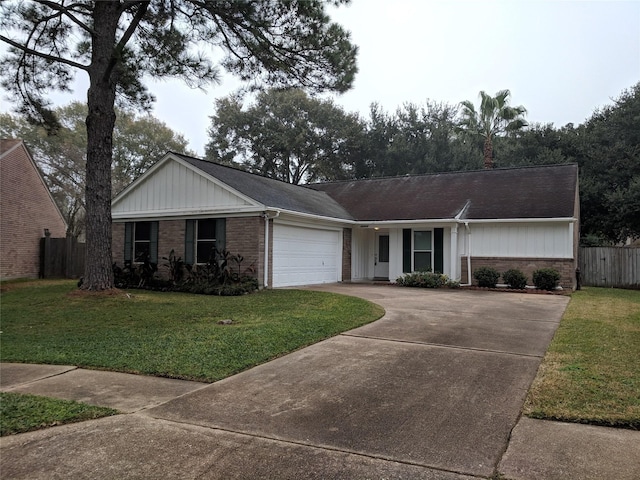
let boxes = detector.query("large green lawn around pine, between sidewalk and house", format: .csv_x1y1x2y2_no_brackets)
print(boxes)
0,281,384,382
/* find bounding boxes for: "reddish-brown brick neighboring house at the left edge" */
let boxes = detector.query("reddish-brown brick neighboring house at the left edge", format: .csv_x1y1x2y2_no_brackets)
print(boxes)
0,140,67,280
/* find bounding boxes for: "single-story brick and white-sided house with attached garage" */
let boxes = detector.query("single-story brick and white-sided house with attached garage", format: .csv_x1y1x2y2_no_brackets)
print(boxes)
112,152,579,288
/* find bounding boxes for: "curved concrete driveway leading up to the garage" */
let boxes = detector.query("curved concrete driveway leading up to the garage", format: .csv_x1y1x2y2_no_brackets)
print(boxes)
2,284,569,480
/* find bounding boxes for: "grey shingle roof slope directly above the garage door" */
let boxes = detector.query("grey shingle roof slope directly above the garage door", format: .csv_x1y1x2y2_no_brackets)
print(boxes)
171,152,353,220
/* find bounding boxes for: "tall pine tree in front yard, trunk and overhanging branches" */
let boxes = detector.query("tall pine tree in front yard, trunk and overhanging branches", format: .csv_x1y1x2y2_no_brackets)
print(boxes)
0,0,356,290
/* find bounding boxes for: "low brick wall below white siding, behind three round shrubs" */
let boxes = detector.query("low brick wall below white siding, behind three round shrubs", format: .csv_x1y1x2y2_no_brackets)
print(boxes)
460,257,576,289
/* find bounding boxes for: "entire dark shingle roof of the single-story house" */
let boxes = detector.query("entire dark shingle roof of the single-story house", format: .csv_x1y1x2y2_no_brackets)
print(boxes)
175,154,578,221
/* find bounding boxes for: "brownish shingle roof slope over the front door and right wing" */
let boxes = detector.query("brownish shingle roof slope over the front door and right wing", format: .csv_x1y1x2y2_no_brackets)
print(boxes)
309,164,578,221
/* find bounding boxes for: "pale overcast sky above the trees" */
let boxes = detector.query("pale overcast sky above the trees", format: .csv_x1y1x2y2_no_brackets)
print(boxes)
0,0,640,155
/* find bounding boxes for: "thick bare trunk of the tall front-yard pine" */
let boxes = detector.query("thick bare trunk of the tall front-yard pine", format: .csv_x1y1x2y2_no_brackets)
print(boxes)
82,2,120,290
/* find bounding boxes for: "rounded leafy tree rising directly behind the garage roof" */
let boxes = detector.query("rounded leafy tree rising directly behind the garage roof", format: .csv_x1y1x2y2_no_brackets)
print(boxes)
206,89,363,184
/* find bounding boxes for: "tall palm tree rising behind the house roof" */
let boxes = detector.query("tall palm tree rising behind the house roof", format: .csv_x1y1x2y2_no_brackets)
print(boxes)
458,90,528,168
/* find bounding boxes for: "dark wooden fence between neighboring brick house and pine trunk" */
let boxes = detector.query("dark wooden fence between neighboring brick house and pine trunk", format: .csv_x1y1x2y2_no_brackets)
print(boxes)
40,235,86,278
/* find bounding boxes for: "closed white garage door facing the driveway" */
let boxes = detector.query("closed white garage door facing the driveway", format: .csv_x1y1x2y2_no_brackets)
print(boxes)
273,223,342,287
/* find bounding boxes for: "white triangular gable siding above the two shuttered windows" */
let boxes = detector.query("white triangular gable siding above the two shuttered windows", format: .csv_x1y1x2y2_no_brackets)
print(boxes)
112,161,253,219
